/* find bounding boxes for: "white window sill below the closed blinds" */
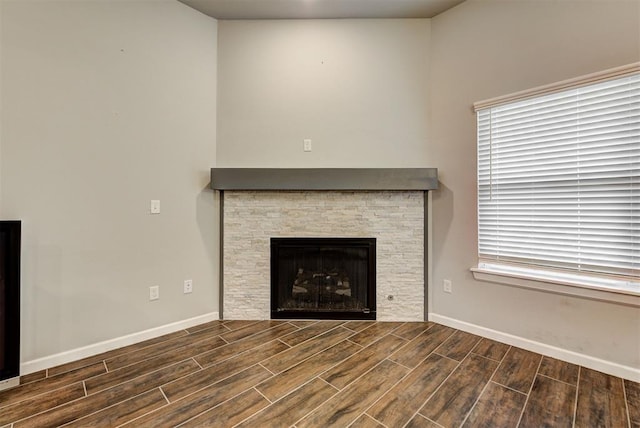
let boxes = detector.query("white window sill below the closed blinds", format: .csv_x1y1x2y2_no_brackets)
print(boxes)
471,263,640,307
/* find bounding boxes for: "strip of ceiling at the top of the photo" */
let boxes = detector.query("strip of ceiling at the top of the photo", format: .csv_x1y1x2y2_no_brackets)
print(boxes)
179,0,464,19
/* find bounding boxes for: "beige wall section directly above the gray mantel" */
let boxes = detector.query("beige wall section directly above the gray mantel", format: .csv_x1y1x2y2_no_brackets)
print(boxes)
217,19,433,167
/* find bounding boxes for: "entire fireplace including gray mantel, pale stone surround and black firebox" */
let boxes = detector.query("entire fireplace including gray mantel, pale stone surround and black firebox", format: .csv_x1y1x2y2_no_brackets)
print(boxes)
212,169,437,321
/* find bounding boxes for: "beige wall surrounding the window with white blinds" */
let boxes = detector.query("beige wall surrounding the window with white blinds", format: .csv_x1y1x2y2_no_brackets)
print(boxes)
428,0,640,369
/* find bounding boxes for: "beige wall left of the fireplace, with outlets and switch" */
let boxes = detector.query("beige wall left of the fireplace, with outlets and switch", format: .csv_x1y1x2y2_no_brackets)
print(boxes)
0,0,219,362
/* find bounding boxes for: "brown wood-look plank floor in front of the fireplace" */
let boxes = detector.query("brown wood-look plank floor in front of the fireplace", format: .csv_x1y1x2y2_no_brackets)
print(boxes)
0,321,640,428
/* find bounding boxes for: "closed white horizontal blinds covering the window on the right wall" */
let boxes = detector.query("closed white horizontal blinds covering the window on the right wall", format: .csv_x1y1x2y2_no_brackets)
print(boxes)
477,72,640,278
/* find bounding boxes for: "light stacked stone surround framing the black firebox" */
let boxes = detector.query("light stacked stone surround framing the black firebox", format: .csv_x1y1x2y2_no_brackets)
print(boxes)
222,191,425,321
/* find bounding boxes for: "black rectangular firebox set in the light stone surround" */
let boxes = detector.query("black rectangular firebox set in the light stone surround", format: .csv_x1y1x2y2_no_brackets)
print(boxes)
271,238,376,320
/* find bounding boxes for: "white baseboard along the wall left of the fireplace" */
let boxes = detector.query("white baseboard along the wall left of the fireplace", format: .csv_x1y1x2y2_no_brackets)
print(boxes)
20,312,220,376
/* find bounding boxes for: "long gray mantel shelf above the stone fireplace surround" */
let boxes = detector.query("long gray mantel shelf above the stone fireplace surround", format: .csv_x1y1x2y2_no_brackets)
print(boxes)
211,168,438,191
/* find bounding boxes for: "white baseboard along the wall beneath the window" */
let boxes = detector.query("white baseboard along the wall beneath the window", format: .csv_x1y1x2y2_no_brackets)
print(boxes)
429,313,640,382
